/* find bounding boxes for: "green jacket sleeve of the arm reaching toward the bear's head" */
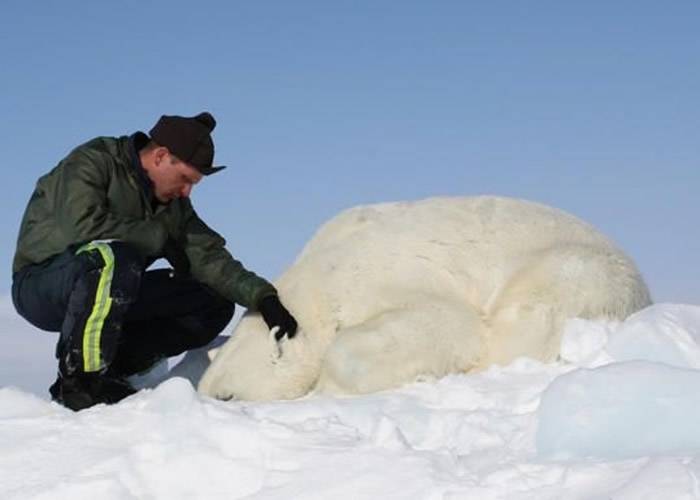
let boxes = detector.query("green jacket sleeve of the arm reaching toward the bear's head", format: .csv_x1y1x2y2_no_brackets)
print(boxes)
184,201,277,309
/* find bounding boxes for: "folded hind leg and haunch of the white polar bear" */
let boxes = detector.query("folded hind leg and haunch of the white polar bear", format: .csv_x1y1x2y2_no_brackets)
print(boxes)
487,244,650,364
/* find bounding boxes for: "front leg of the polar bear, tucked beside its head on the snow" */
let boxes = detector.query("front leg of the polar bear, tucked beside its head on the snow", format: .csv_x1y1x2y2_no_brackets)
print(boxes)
316,300,484,394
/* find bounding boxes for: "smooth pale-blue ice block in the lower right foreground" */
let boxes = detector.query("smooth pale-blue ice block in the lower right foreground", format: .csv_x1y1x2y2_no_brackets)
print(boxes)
537,361,700,459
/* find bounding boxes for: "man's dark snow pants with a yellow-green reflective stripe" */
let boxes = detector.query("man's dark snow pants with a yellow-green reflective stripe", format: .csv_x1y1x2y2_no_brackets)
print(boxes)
12,241,234,376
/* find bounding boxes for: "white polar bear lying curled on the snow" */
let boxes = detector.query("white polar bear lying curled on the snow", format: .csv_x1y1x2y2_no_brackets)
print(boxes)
199,196,650,400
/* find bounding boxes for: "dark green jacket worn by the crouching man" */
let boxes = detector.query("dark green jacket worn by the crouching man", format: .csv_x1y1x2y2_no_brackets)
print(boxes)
12,134,276,309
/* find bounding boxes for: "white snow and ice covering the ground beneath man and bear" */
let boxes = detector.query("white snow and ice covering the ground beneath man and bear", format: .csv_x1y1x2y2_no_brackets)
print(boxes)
0,304,700,500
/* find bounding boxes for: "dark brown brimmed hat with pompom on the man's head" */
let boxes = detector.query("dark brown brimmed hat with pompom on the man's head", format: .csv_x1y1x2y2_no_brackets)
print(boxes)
149,111,226,175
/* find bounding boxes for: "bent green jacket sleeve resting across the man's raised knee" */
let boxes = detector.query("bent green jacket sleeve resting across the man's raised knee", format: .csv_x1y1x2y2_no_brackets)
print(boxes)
54,151,167,256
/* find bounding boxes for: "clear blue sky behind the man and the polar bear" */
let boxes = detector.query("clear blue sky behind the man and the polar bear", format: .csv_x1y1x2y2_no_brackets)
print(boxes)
0,0,700,303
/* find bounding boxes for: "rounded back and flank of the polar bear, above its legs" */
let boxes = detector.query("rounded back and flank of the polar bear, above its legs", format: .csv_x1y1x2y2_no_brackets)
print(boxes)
278,196,637,334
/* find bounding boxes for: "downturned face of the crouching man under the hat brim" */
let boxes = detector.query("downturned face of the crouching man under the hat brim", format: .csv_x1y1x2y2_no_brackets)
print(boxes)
148,148,204,203
